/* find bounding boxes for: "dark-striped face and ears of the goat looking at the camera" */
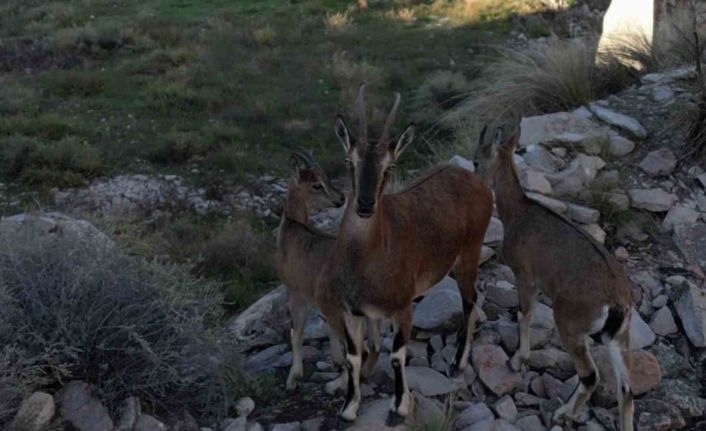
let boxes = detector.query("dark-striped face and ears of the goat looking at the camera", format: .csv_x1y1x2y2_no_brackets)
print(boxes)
336,116,414,219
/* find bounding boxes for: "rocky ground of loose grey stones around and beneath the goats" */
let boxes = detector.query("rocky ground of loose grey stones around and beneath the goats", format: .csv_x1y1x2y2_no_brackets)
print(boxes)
4,68,706,431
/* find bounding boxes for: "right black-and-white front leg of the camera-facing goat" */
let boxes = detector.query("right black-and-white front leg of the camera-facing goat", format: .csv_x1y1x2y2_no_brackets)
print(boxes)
387,305,412,425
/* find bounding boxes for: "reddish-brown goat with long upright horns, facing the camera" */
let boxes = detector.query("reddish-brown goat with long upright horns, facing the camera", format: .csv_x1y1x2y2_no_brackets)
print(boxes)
322,86,493,422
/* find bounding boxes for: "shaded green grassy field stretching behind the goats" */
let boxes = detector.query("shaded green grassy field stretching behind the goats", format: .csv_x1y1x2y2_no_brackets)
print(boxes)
0,0,556,191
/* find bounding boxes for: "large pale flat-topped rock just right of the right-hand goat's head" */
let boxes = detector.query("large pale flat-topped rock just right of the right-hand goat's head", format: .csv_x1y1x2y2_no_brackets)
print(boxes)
520,112,608,154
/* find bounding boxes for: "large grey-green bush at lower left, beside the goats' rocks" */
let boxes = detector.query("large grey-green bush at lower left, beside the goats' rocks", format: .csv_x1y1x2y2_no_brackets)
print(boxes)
0,224,245,425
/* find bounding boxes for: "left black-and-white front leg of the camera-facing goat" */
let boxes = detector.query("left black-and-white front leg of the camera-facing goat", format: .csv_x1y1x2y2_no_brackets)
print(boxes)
340,314,365,421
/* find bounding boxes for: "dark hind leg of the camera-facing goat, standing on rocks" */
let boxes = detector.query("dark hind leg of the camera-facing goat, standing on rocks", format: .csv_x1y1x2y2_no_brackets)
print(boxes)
449,248,480,375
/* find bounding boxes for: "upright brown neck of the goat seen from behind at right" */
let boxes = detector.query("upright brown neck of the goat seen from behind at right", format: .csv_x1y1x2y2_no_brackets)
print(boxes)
493,153,527,223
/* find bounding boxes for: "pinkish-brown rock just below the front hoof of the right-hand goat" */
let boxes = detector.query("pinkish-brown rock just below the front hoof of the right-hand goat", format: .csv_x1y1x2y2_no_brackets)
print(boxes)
471,344,523,396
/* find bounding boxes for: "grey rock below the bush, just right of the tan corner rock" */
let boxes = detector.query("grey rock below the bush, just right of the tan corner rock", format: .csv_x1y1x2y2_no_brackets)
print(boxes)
57,381,113,431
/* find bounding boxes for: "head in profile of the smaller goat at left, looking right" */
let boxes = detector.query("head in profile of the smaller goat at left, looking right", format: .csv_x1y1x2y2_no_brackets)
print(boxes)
292,153,346,209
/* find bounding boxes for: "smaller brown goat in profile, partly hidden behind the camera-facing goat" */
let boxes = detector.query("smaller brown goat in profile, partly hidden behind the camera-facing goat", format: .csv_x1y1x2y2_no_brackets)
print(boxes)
276,153,380,393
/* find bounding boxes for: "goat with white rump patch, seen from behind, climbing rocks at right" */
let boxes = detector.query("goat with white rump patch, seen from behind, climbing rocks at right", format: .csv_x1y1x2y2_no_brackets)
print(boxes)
472,129,634,431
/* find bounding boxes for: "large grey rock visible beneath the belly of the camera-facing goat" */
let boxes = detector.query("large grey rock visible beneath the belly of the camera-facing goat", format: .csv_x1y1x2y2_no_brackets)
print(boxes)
414,277,463,331
